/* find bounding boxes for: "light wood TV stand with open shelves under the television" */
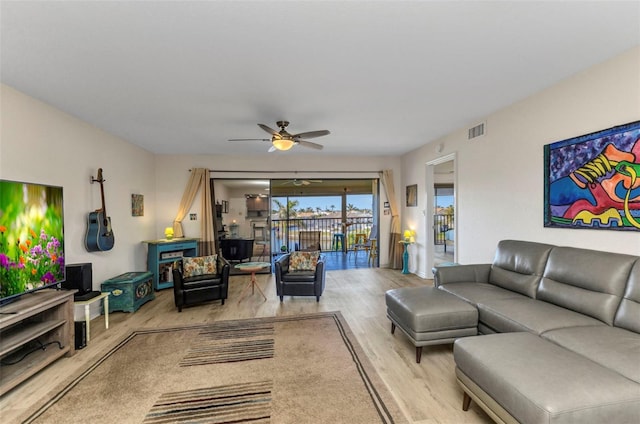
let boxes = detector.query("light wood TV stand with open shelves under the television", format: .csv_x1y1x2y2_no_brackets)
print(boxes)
0,289,75,396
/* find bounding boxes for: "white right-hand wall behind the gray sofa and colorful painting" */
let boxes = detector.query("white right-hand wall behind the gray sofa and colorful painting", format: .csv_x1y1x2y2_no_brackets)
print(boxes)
402,47,640,277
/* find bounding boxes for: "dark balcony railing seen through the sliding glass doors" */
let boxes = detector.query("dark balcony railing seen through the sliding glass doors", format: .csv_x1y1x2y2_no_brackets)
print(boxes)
271,216,373,251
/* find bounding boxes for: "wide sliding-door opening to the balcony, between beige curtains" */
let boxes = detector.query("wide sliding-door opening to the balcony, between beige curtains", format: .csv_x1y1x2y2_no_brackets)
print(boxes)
212,178,379,269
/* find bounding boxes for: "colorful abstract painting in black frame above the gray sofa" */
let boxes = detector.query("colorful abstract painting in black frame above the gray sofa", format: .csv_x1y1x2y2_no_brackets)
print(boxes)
544,121,640,231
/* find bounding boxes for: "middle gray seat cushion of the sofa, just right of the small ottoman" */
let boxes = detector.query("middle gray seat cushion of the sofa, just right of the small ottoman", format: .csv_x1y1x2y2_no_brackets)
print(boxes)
478,297,604,334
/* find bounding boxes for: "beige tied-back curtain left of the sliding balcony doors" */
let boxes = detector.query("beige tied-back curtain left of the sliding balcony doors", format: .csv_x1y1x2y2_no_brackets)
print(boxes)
173,168,215,255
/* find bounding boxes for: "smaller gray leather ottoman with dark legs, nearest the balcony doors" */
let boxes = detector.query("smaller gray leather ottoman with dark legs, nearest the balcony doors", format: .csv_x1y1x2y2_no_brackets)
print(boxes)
385,286,478,363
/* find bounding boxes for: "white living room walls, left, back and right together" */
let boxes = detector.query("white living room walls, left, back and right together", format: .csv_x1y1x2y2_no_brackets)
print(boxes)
8,47,640,289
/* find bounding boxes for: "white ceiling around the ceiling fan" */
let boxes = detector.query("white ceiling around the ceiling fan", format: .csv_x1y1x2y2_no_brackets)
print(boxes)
0,0,640,155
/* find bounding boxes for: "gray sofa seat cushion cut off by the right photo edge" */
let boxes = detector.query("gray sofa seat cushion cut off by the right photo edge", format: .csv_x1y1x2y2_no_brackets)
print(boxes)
542,325,640,384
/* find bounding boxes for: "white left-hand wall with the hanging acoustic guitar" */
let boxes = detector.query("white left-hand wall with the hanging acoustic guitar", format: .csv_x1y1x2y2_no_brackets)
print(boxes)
0,85,156,290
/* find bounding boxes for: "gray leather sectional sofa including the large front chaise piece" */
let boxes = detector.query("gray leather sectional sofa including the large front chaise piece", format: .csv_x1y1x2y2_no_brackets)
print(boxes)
434,240,640,424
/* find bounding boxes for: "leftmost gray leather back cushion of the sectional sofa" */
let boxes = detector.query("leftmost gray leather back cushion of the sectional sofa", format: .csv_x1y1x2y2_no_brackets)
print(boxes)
489,240,553,298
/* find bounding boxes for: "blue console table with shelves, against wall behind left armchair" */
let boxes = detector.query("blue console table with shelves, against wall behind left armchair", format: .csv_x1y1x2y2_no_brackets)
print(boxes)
143,238,198,290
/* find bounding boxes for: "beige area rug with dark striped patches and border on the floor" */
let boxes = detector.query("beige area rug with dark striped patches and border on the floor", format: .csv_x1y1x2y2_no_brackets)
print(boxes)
23,312,406,424
